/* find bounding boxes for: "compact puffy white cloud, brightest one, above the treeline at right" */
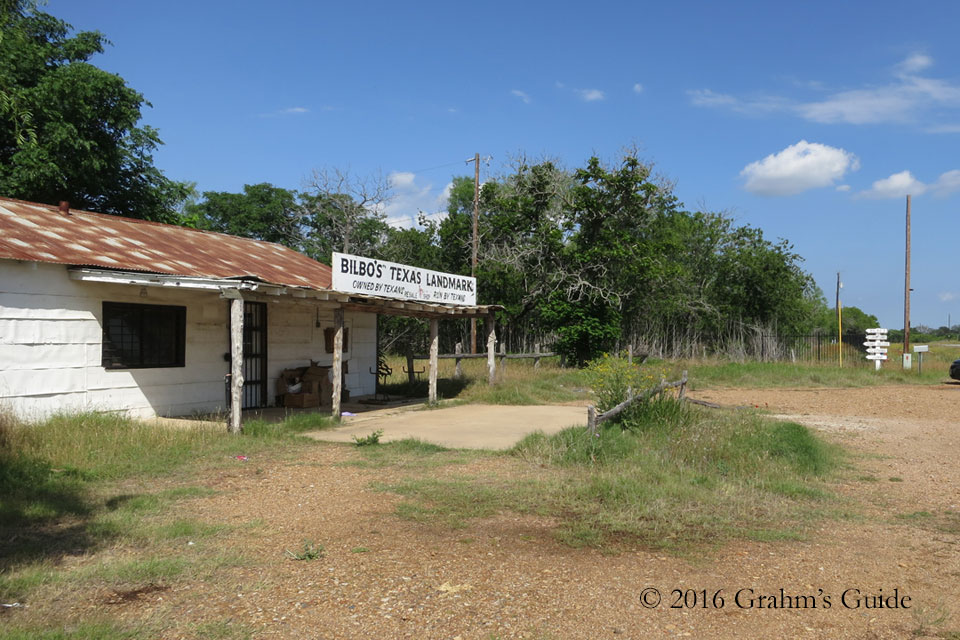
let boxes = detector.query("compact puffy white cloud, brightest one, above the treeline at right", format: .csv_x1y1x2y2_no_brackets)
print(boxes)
740,140,860,196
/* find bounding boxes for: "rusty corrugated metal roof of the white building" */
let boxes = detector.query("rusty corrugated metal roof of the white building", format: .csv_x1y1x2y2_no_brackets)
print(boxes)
0,198,331,289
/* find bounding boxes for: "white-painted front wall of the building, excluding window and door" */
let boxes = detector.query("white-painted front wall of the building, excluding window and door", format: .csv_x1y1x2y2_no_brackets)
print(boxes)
0,259,376,419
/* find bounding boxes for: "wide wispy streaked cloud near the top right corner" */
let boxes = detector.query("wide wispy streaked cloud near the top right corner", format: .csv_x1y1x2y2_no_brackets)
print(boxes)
687,53,960,133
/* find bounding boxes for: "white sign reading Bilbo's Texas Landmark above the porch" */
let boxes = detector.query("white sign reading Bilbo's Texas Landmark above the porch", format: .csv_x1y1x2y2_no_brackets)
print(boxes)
333,252,477,305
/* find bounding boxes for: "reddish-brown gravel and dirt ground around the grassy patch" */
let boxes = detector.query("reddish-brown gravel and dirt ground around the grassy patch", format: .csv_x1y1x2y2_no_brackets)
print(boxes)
9,384,960,640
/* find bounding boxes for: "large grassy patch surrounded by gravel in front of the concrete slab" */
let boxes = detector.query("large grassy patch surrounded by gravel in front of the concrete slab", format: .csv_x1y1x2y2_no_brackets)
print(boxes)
382,400,842,551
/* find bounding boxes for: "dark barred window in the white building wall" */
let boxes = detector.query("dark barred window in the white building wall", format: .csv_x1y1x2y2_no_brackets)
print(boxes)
101,302,187,369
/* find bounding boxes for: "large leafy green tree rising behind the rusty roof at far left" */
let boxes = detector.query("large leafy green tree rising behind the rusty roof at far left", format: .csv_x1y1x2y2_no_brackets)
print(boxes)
0,0,188,222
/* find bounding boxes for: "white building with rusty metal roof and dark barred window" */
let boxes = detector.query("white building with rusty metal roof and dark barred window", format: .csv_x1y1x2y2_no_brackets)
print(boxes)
0,198,377,419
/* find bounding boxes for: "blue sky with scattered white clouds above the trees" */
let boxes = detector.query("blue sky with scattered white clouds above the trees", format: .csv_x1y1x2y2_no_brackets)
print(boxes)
46,0,960,327
